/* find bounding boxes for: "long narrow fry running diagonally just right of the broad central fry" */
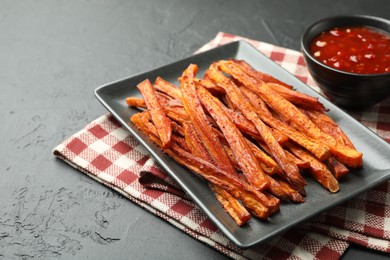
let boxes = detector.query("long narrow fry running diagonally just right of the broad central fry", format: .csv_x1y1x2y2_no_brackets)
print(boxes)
206,65,306,193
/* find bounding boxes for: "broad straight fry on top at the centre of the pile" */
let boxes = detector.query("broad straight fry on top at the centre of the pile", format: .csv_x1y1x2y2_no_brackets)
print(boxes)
197,86,269,190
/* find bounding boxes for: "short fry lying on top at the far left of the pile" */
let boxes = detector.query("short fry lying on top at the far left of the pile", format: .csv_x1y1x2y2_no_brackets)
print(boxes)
137,80,172,148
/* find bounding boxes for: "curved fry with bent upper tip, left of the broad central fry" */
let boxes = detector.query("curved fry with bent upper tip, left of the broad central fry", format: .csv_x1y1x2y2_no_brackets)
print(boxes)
180,64,235,174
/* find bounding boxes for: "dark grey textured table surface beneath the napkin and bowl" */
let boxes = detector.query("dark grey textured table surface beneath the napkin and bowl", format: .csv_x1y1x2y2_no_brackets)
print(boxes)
0,0,390,259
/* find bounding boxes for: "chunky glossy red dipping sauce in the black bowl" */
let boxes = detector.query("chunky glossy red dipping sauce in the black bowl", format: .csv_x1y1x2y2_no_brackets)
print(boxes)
309,27,390,74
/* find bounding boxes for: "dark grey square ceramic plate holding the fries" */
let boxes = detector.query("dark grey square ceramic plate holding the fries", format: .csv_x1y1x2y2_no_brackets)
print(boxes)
95,42,390,248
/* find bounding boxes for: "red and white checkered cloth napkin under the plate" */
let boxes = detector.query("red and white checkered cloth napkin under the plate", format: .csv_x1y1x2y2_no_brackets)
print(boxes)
54,33,390,259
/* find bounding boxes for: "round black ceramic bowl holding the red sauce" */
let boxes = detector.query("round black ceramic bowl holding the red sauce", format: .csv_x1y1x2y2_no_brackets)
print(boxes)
301,15,390,109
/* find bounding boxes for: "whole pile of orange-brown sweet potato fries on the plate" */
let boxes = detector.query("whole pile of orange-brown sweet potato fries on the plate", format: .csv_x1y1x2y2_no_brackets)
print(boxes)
126,59,363,226
